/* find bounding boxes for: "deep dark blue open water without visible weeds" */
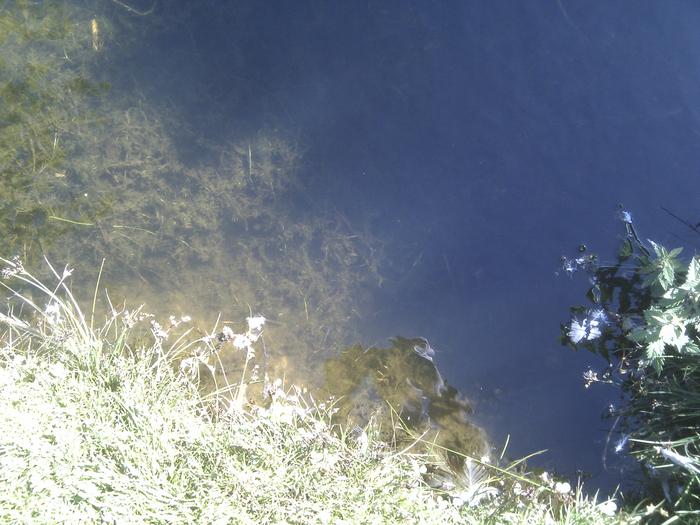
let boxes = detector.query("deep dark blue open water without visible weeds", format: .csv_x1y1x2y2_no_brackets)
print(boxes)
113,0,700,489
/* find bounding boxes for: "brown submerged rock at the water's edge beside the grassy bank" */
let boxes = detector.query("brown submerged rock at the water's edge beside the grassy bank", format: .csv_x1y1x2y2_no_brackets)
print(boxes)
323,337,489,469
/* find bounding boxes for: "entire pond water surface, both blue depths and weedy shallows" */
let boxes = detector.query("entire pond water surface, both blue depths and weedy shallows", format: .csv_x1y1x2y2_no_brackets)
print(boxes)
0,0,700,490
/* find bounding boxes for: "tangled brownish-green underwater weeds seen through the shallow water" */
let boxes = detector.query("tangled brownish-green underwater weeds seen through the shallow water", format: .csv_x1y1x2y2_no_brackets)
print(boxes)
0,1,388,388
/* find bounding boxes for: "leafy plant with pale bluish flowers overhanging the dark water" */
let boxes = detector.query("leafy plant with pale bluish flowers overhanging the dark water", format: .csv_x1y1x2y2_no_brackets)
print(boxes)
563,211,700,523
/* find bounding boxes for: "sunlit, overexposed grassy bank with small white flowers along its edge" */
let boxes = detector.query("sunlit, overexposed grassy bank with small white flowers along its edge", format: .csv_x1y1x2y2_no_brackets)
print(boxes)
0,259,622,524
